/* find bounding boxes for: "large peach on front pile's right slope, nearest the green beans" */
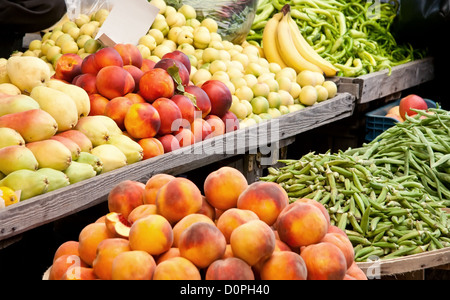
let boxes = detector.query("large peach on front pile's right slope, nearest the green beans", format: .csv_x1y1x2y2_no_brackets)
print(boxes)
276,202,328,248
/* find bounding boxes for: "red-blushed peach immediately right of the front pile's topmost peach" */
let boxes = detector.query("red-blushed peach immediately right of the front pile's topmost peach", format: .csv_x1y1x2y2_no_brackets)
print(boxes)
237,181,289,225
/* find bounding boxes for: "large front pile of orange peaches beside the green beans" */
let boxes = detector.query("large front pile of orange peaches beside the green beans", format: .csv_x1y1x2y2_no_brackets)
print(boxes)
47,167,367,280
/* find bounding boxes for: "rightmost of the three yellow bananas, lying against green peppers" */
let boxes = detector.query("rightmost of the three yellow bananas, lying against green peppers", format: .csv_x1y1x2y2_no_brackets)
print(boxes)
286,13,338,76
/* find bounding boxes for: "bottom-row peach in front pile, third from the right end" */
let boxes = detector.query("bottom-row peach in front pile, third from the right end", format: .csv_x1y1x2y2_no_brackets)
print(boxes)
259,251,308,280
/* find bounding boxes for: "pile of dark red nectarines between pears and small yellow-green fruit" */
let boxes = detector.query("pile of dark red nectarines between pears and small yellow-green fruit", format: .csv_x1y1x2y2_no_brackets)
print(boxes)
54,44,239,159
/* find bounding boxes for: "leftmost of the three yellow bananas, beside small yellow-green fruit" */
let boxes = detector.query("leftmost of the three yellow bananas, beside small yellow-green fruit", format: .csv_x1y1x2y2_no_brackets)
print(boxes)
262,12,287,68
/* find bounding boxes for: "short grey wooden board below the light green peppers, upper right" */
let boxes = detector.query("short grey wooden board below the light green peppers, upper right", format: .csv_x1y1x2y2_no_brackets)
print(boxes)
337,57,435,104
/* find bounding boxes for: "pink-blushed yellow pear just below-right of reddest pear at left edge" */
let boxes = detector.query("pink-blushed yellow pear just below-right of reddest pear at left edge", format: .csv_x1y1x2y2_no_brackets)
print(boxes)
25,139,72,171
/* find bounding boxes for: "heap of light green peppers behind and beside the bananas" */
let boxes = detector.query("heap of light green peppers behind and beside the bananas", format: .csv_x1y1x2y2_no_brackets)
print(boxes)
247,0,426,77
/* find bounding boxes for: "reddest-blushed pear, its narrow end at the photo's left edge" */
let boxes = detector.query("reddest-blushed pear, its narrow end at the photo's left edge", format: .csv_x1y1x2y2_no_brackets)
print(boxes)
0,109,58,143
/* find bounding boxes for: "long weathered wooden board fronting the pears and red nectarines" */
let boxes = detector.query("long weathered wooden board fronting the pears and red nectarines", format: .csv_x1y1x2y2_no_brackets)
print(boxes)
0,93,355,244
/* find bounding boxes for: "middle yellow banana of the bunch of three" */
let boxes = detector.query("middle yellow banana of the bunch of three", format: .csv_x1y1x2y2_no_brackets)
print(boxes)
277,12,323,73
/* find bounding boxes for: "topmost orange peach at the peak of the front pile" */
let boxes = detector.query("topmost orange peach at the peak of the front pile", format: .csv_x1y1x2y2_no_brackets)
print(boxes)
203,167,248,210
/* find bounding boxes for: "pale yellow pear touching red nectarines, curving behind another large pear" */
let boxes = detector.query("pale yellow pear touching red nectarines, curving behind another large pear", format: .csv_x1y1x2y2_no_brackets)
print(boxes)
46,79,91,118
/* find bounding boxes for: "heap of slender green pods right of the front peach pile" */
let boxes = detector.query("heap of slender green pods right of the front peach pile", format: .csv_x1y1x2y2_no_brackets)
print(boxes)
260,108,450,261
